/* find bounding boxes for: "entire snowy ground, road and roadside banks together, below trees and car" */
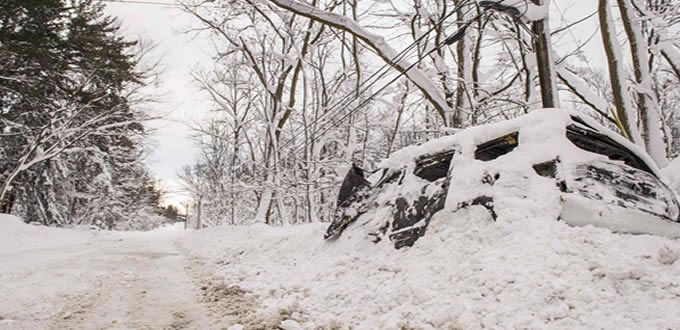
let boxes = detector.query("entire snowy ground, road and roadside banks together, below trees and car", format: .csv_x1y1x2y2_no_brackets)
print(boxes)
0,213,680,329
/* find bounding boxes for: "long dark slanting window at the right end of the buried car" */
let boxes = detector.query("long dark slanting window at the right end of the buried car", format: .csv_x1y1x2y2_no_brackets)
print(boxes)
567,125,653,174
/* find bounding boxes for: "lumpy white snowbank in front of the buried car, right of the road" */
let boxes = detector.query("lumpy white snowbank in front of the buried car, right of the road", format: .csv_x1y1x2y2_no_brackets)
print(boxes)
183,213,680,329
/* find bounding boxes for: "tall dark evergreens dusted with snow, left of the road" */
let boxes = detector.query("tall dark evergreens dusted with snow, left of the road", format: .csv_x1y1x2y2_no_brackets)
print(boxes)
0,0,167,229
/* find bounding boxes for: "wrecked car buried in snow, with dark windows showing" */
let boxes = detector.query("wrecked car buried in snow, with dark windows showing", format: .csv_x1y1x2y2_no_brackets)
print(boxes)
324,109,680,248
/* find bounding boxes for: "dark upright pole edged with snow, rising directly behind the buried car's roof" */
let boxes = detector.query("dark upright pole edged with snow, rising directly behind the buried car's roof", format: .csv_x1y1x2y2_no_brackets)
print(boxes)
532,0,560,108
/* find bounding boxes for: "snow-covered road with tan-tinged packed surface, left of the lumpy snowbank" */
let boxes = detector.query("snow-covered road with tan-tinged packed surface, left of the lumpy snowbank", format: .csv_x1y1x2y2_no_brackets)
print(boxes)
0,228,215,329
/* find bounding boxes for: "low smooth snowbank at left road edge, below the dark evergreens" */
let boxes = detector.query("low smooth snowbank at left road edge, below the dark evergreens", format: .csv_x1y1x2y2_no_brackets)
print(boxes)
0,213,102,256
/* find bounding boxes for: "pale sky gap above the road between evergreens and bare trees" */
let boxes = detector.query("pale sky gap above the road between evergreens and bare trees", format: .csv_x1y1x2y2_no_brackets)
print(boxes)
101,0,212,209
